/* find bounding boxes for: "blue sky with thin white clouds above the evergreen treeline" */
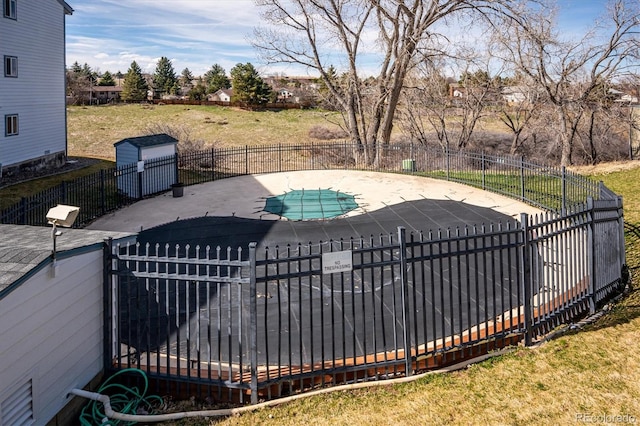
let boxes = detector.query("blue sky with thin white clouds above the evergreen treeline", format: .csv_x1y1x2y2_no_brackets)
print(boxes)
66,0,606,76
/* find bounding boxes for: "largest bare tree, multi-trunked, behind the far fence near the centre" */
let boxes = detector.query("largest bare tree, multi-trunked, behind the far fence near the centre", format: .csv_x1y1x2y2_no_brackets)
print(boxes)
254,0,535,162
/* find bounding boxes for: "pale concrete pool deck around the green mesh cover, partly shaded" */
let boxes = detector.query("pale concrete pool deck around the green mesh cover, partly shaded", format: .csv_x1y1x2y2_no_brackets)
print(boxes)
86,170,541,232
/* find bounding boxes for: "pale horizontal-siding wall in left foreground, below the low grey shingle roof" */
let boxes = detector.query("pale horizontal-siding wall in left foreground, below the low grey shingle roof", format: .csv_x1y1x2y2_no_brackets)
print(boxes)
0,248,103,425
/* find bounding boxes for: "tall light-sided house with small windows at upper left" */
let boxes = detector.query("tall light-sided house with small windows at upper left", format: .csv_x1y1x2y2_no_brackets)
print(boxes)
0,0,73,178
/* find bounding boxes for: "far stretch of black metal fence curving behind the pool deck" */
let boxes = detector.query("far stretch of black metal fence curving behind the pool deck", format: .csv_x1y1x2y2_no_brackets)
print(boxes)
0,142,615,227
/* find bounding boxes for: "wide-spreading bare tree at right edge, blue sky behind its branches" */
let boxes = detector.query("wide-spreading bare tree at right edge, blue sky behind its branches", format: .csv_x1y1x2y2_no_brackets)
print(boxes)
496,0,640,165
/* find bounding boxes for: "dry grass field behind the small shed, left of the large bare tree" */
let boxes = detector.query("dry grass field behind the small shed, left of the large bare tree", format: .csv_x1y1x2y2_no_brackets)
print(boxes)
67,104,339,160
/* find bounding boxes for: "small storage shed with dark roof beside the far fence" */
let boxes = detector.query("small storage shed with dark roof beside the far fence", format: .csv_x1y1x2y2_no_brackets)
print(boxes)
114,133,178,198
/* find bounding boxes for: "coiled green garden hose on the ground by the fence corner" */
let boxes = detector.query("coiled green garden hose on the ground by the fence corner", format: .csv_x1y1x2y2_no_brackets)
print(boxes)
80,368,164,426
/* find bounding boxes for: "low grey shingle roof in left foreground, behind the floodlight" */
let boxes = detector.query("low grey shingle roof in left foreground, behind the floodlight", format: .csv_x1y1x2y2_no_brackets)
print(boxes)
0,225,135,297
